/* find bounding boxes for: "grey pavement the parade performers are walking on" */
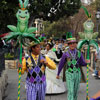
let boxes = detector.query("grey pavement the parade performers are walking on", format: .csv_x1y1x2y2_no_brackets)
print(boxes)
3,69,100,100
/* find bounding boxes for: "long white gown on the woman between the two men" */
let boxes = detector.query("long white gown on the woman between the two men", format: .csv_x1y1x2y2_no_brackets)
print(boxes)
41,49,66,94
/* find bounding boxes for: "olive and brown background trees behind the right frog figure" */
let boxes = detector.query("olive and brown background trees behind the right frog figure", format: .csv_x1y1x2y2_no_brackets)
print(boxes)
41,3,100,39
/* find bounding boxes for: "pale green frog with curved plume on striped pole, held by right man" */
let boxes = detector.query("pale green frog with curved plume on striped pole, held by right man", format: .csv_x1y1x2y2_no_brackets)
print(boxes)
77,6,99,100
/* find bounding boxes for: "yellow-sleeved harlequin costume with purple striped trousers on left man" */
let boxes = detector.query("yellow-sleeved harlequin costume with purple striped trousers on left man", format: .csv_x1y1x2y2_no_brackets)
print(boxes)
21,41,56,100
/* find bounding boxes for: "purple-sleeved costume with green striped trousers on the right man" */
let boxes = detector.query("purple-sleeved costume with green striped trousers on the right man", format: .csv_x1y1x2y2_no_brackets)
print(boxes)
57,33,86,100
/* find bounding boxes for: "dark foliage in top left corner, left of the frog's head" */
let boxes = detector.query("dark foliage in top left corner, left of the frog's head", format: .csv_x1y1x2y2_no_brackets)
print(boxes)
0,0,18,34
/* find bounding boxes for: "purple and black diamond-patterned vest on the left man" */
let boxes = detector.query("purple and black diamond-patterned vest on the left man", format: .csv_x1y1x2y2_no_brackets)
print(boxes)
26,55,46,83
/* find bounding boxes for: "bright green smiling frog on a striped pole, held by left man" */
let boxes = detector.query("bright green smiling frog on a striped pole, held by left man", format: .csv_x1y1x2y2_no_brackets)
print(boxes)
5,0,39,100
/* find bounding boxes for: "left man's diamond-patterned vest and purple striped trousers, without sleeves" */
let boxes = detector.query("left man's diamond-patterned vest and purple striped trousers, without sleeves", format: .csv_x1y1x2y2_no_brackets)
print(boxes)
26,55,46,100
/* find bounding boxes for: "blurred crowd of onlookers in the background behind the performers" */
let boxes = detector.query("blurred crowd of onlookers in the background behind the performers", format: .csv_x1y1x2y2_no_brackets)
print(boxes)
0,36,100,78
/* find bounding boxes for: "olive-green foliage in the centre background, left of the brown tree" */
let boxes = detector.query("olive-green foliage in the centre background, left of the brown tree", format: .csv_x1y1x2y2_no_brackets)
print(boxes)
42,17,71,37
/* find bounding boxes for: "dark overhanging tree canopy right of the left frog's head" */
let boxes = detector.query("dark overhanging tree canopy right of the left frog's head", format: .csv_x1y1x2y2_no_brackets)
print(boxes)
30,0,81,21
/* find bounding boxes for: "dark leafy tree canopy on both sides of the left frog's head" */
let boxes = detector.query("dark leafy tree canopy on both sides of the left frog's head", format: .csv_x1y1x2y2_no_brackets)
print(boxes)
0,0,81,33
